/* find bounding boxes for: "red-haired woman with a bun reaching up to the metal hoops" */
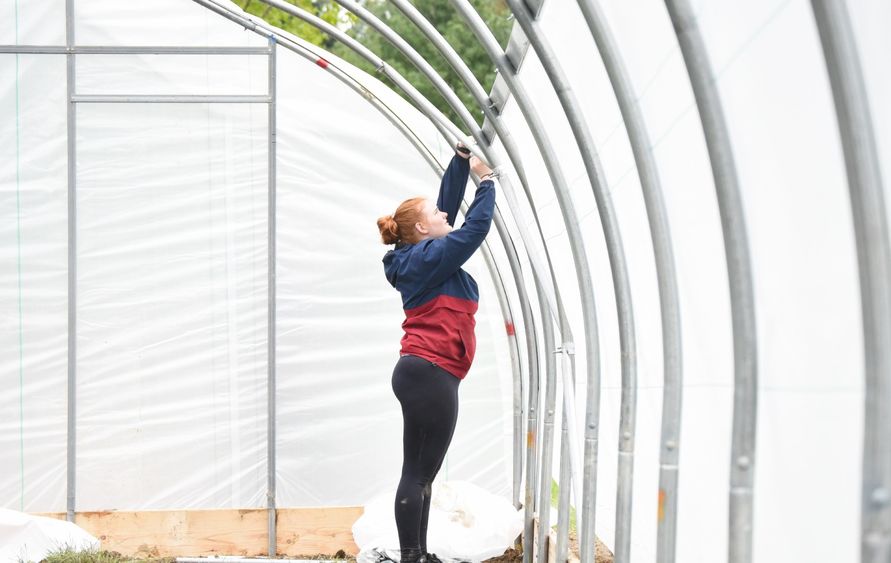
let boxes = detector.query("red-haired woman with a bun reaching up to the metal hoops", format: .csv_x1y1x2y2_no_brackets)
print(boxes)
377,144,495,563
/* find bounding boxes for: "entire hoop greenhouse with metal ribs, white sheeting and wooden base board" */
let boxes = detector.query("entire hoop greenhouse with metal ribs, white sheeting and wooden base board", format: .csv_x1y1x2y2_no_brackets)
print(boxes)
0,0,891,563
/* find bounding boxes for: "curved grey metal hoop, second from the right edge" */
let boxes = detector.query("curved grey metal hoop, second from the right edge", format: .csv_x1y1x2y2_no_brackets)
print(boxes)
665,0,758,563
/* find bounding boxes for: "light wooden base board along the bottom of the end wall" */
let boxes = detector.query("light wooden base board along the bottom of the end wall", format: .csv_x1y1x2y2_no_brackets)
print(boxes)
42,506,362,557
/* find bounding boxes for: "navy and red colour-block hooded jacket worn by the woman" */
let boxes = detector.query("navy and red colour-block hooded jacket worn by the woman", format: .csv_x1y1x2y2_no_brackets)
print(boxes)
384,155,495,379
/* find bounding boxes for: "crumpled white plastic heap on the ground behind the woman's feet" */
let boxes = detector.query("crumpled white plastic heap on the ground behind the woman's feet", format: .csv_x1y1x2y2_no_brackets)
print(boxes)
353,481,523,563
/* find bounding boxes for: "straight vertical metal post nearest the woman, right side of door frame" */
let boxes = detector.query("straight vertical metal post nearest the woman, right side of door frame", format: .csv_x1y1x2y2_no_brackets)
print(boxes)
266,37,276,556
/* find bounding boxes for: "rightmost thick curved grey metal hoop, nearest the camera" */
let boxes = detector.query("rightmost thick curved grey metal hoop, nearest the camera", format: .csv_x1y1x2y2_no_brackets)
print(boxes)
811,0,891,563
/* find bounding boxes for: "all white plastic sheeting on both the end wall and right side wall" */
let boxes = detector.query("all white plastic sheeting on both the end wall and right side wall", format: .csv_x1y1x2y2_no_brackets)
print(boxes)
0,0,891,563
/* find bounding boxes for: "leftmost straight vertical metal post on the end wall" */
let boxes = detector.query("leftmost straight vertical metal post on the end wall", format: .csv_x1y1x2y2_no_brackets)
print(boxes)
65,0,77,522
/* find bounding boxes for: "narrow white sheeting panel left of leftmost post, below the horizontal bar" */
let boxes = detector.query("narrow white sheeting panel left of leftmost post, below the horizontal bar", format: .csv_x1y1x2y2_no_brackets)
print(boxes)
0,50,68,510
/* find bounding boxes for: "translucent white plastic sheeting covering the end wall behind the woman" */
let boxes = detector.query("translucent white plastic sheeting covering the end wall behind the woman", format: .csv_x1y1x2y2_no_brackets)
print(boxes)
0,0,511,511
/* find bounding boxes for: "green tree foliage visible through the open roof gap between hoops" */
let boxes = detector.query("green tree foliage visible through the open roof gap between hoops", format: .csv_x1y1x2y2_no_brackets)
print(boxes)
236,0,513,130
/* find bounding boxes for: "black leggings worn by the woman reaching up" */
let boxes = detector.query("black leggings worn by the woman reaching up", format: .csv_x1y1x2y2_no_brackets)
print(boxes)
393,356,461,561
